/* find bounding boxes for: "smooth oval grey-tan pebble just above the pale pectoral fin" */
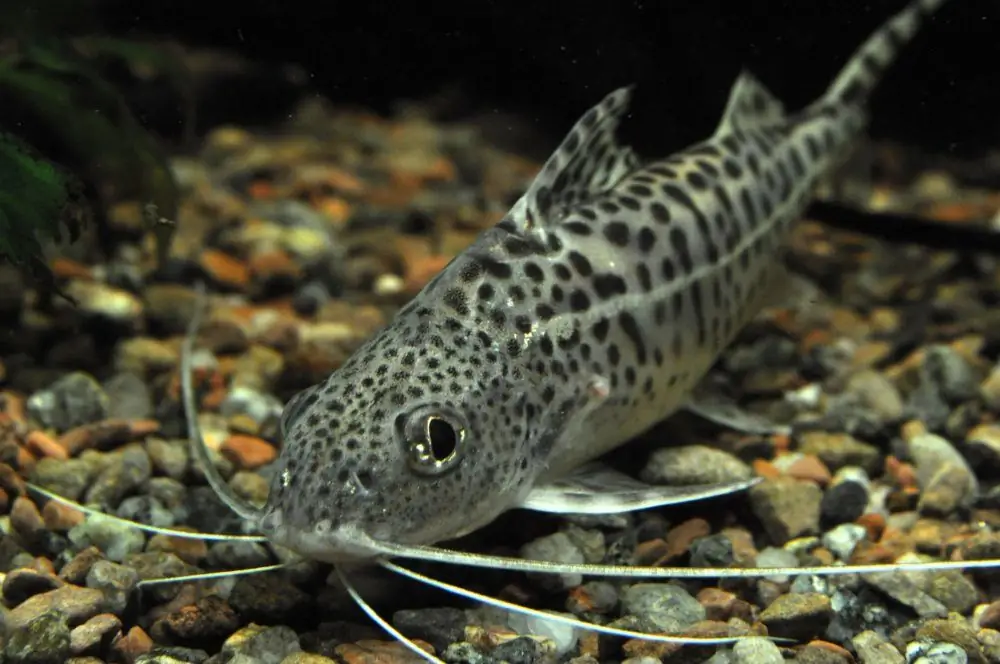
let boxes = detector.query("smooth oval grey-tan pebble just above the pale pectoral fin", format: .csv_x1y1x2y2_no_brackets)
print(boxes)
639,445,753,486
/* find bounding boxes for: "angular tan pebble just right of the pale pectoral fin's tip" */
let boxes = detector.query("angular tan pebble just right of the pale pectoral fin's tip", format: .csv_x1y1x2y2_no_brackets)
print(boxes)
749,477,823,544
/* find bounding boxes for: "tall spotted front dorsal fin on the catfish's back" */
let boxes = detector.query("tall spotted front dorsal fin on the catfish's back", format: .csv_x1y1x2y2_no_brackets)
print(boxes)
512,86,639,231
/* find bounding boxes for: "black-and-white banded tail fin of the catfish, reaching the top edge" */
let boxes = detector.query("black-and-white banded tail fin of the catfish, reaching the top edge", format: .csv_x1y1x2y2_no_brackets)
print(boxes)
816,0,947,106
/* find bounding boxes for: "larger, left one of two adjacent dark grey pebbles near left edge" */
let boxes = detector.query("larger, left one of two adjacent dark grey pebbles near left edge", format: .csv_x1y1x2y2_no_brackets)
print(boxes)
27,371,110,432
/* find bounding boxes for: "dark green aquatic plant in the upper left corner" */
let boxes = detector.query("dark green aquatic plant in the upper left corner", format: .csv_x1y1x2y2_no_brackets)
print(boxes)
0,0,186,290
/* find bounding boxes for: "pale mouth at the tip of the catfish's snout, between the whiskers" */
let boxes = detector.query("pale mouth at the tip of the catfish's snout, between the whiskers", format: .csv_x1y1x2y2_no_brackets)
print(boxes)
260,510,389,564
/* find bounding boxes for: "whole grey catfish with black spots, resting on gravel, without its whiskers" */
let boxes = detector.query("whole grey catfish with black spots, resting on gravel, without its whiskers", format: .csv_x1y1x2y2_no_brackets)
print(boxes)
260,0,943,562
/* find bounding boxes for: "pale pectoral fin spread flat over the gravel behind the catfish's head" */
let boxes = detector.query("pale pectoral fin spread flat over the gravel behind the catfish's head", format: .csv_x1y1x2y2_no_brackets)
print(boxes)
519,463,759,514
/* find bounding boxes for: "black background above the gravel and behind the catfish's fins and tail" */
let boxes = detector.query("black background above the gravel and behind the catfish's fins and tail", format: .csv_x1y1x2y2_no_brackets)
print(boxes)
97,0,1000,160
